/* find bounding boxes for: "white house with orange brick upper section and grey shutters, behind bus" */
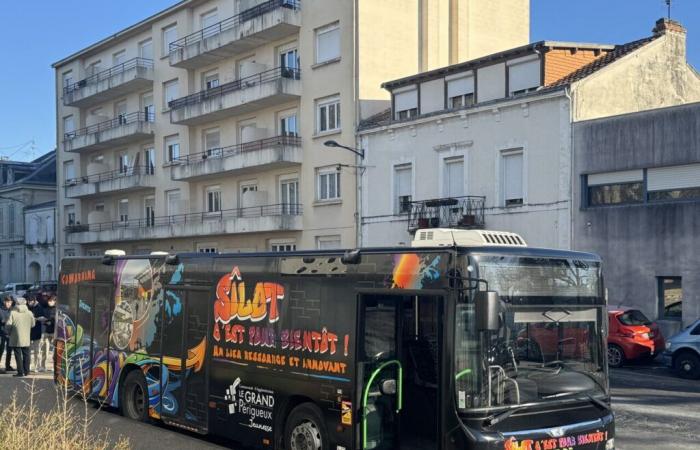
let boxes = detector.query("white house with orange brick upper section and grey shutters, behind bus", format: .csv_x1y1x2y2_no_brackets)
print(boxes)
360,20,700,250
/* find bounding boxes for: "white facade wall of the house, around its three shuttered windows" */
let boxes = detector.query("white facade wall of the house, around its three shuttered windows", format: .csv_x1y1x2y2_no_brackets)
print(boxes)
362,91,571,249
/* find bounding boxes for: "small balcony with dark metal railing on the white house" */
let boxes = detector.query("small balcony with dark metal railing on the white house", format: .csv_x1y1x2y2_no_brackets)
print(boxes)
401,196,486,233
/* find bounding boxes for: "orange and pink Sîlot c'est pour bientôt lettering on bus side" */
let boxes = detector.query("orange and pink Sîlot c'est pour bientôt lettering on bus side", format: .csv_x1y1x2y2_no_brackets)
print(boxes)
213,266,350,381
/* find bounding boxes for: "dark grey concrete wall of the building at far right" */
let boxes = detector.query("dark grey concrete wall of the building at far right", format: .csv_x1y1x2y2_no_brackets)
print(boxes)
573,103,700,334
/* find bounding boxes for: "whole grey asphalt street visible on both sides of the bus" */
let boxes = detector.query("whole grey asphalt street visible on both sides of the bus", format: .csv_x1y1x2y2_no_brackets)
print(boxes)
0,365,700,450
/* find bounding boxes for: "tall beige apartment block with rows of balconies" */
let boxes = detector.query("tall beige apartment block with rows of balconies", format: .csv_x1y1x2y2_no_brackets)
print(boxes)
53,0,529,256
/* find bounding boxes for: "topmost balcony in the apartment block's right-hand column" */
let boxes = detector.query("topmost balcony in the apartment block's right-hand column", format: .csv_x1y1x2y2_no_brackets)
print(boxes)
168,0,301,69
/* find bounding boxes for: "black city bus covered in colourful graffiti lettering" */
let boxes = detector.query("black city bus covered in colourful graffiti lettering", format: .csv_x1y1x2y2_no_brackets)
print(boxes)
54,229,614,450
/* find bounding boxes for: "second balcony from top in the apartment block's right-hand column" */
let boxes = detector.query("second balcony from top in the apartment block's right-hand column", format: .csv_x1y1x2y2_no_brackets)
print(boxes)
168,67,301,125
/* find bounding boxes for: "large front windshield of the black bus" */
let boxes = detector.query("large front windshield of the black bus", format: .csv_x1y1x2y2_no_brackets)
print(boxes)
455,255,607,410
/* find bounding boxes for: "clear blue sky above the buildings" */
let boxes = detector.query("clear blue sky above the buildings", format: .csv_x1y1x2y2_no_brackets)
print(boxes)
0,0,700,160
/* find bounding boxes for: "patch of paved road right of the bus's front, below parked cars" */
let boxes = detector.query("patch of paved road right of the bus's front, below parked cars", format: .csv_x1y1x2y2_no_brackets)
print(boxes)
610,365,700,450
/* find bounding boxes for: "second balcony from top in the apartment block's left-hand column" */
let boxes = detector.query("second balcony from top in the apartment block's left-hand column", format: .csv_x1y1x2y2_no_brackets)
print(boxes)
63,112,155,152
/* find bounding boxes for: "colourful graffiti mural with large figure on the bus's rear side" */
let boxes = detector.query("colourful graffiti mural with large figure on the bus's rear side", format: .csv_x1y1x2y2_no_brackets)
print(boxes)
56,259,206,418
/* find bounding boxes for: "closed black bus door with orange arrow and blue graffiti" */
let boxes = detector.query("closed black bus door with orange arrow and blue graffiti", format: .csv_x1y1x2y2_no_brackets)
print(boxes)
160,285,210,433
